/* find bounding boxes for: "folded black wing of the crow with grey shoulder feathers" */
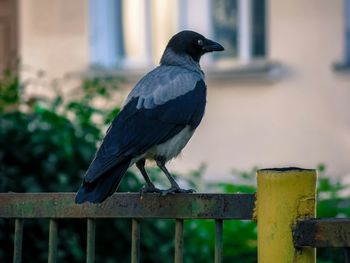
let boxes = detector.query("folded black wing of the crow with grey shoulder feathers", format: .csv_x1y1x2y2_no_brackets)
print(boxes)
84,71,206,183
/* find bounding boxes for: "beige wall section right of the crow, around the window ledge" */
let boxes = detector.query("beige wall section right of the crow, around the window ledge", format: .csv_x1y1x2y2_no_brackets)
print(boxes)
170,0,350,180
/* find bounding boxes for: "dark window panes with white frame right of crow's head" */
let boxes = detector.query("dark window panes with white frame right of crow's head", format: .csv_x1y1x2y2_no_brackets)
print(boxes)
212,0,266,63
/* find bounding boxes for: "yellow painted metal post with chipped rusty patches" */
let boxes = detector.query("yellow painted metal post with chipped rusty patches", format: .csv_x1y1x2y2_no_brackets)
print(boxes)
256,168,317,263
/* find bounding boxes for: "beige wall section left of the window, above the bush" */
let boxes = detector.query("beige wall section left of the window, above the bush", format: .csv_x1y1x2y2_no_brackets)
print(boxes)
19,0,88,77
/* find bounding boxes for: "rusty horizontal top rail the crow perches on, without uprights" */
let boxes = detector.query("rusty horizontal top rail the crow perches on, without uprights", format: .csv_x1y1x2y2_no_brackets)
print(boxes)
0,193,255,220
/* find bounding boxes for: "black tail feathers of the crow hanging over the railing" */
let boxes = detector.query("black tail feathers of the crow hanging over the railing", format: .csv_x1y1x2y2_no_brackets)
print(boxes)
75,161,130,204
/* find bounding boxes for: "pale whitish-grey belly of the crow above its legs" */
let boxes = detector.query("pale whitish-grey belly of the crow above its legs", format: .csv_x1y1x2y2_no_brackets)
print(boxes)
152,126,194,161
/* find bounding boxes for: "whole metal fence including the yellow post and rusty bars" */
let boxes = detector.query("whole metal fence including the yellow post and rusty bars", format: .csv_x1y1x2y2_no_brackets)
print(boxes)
0,168,350,263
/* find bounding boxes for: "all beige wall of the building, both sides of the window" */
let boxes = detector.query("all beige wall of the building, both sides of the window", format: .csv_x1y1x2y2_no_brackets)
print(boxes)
20,0,350,179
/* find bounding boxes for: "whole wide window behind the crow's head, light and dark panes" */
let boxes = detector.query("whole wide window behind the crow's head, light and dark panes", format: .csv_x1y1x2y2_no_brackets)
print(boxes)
89,0,266,68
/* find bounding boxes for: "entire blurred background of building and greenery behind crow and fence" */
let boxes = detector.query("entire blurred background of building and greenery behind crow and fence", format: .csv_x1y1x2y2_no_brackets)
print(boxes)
0,0,350,262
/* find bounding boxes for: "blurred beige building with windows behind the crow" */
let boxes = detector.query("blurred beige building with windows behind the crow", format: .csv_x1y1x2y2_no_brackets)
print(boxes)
0,0,350,178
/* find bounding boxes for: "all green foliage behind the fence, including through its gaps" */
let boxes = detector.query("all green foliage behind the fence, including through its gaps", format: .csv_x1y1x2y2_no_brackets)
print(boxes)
0,72,350,263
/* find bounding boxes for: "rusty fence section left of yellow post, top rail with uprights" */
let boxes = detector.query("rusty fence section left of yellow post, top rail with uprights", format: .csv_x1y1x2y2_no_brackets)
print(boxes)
0,193,255,263
